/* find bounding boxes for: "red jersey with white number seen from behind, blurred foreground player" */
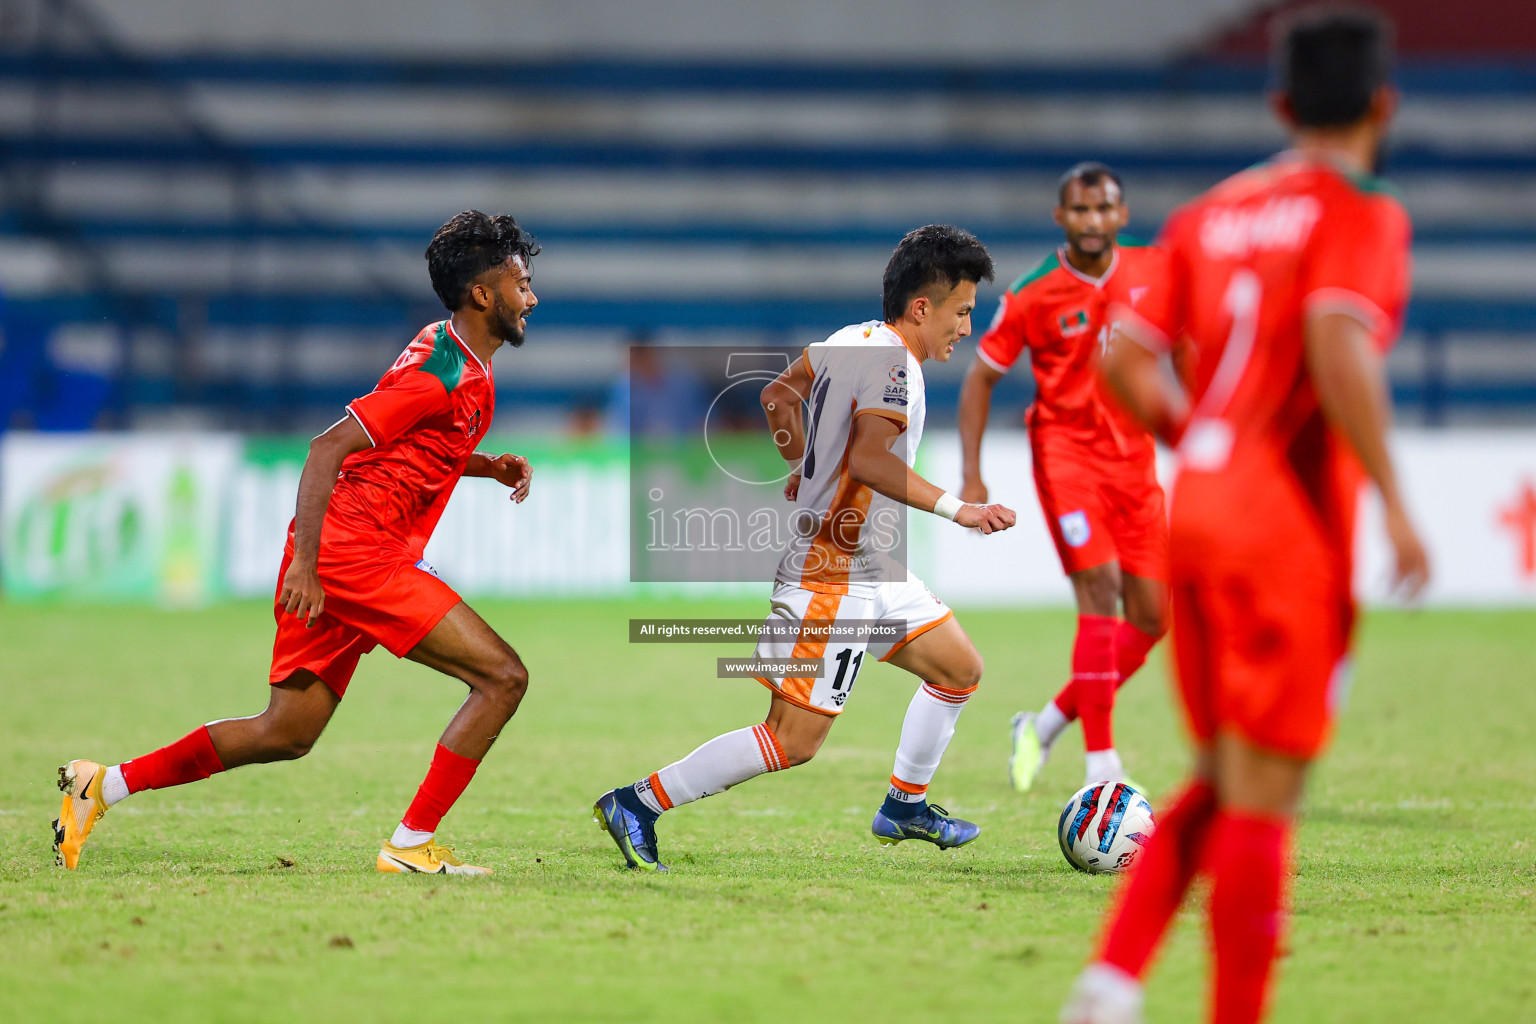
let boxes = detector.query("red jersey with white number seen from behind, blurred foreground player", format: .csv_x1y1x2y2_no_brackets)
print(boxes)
1112,154,1410,588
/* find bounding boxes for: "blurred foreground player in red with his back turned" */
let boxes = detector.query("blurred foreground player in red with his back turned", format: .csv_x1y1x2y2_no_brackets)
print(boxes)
1061,9,1428,1024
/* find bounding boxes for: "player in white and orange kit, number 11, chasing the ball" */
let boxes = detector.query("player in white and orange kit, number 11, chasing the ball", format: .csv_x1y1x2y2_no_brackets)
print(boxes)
593,224,1015,870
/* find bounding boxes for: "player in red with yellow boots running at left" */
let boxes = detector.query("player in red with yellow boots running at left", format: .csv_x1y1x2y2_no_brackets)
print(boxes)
54,210,539,875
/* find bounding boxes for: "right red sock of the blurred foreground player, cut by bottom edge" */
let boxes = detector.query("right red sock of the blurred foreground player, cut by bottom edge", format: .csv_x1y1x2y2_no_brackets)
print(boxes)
1209,811,1290,1024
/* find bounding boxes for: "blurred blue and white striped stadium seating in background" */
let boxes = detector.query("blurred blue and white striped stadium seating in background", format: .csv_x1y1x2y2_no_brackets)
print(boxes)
0,46,1536,430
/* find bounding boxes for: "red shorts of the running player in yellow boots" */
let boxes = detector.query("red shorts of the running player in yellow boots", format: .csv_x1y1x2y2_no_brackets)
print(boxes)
269,547,459,697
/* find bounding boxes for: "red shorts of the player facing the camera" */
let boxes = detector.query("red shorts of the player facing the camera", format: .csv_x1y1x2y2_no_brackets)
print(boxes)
1029,431,1167,580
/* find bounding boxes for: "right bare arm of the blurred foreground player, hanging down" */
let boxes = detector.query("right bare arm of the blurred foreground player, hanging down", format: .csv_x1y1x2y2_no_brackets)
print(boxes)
1307,313,1430,599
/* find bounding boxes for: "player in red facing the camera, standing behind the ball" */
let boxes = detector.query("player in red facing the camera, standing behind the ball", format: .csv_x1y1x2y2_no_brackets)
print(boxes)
960,163,1167,791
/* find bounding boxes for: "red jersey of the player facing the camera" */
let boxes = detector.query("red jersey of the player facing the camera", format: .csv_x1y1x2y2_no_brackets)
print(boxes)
977,244,1166,459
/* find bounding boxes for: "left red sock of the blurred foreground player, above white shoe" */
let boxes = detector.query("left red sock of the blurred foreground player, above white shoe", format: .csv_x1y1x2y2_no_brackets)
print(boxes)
1095,780,1217,978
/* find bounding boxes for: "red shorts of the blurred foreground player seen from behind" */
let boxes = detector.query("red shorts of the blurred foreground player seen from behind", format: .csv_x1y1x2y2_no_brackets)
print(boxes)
1169,553,1355,760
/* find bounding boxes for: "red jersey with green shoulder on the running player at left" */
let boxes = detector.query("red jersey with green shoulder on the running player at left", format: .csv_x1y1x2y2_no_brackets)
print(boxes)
321,321,496,559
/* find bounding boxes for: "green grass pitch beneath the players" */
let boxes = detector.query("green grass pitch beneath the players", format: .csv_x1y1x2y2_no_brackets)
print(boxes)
0,602,1536,1024
